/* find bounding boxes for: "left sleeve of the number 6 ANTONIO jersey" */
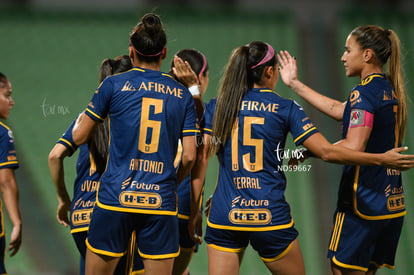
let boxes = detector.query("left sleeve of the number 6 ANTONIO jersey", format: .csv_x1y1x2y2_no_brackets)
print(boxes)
85,78,113,122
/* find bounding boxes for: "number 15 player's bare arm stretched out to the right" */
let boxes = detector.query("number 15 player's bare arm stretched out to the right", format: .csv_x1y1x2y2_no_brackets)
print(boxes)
303,133,414,170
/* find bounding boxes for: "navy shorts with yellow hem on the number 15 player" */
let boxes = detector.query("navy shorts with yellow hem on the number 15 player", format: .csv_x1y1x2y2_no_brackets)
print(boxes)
204,226,298,262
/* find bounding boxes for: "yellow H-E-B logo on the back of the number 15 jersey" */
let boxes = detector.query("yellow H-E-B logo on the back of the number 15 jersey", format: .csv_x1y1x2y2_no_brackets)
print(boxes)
229,208,272,225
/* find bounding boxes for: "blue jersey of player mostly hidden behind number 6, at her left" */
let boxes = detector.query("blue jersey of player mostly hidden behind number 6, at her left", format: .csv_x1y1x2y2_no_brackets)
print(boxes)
58,120,101,233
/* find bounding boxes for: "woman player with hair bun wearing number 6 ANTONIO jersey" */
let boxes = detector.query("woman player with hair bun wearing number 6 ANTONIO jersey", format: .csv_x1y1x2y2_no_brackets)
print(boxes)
72,14,199,275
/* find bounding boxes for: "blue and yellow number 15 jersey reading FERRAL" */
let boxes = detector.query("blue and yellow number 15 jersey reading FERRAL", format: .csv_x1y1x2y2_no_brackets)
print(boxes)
203,89,318,231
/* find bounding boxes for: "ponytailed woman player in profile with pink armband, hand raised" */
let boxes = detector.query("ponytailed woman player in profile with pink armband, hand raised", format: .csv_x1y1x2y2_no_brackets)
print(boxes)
280,25,407,274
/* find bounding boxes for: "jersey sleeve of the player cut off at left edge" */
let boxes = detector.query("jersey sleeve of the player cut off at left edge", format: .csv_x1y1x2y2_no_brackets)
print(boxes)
0,128,19,169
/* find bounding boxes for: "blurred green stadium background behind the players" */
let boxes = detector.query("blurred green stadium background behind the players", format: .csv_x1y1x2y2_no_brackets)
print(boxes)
0,0,414,275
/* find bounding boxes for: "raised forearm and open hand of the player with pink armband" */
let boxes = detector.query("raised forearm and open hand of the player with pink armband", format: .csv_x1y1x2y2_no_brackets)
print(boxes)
278,51,346,121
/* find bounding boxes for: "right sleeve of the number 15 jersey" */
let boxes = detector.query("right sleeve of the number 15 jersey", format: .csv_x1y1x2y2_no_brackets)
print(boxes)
289,101,319,146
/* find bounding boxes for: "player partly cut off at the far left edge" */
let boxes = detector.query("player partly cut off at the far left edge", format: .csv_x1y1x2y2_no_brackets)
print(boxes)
0,73,22,274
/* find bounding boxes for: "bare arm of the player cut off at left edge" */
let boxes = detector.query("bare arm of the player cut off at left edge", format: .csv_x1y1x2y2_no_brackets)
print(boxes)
0,168,22,256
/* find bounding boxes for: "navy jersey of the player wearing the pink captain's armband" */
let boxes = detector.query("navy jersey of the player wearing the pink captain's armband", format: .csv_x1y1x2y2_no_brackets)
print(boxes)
338,74,405,220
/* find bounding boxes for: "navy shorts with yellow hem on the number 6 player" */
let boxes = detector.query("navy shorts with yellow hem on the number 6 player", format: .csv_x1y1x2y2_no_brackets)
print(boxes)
86,206,179,259
